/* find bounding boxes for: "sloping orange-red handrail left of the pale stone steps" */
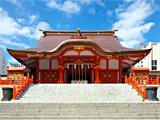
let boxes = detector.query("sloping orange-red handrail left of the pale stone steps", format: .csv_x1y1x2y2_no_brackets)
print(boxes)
13,76,33,100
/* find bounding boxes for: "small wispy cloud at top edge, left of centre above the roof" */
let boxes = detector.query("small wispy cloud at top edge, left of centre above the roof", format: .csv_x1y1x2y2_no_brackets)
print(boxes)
47,0,80,14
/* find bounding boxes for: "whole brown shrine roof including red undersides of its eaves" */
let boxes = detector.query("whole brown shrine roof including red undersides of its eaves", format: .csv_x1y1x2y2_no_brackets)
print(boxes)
7,30,151,70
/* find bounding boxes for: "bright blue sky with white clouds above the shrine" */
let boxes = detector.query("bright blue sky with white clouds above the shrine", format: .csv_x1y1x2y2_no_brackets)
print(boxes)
0,0,160,63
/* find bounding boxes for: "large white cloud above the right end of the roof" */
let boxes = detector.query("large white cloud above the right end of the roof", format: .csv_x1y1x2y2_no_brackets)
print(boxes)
112,0,154,47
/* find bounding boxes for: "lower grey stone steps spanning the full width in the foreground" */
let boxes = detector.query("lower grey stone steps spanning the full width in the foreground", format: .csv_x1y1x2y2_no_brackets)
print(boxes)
0,102,160,120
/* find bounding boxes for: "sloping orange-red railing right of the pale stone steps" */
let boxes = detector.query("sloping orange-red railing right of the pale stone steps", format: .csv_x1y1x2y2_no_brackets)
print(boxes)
125,76,146,100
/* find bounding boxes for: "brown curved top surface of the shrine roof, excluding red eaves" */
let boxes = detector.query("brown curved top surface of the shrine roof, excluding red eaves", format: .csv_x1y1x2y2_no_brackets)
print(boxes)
7,31,151,55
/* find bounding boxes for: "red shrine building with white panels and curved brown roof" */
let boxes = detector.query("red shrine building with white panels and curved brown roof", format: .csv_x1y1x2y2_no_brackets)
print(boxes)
7,28,151,84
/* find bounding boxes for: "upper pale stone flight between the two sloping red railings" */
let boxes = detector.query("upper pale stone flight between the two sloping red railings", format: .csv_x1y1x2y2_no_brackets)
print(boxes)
16,84,143,103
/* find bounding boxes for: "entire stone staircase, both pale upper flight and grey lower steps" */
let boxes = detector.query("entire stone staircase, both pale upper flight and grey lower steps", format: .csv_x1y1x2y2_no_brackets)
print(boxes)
0,84,160,120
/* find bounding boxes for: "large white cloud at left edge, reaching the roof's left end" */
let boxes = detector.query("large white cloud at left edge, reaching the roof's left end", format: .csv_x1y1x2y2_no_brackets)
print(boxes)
0,7,50,39
